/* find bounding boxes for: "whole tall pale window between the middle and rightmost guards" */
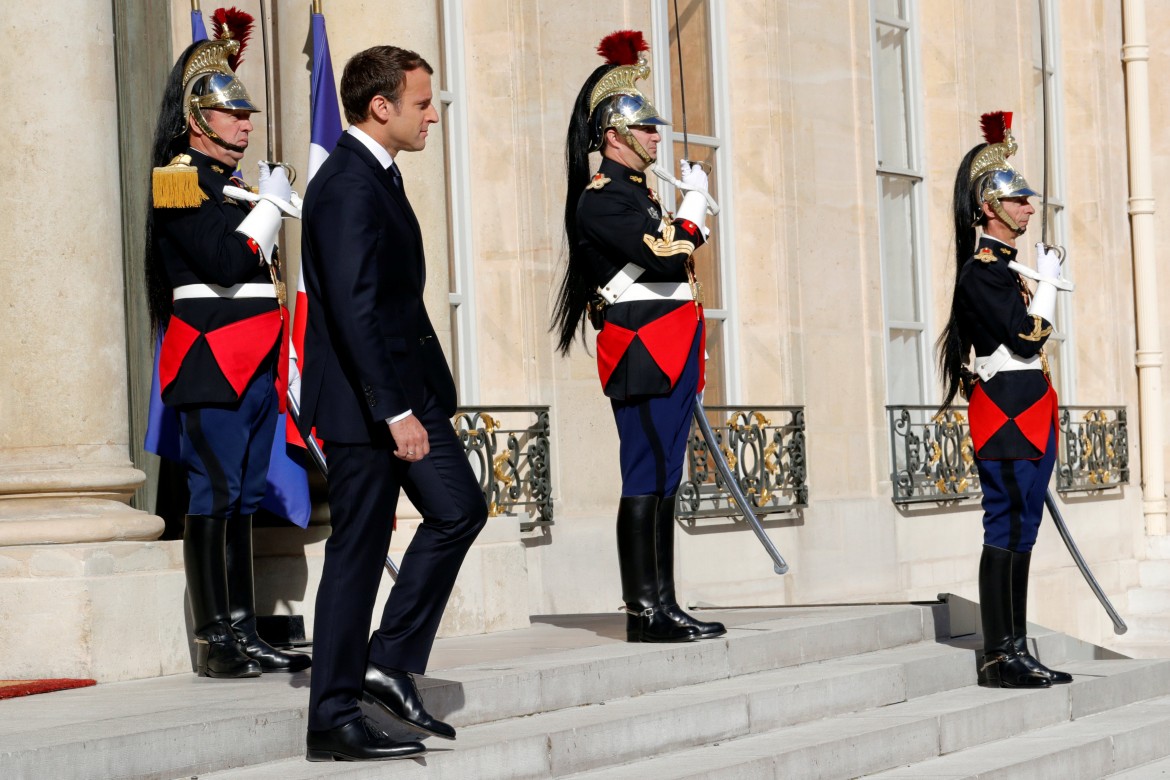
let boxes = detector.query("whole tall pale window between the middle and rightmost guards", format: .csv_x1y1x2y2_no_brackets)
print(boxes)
872,0,934,405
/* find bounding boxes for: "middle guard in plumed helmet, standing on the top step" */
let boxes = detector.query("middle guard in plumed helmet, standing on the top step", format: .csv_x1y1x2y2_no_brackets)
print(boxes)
553,30,725,642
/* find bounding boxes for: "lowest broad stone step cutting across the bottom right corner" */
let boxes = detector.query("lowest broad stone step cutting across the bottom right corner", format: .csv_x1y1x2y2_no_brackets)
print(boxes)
870,696,1170,780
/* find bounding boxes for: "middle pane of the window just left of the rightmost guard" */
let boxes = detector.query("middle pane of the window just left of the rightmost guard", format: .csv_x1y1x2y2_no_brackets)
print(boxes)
878,175,922,323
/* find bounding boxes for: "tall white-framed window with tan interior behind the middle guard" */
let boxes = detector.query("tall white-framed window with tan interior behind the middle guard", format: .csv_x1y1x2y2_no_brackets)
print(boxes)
651,0,739,406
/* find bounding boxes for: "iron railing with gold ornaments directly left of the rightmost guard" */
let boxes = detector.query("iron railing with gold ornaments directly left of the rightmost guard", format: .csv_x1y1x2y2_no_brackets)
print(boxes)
886,406,980,504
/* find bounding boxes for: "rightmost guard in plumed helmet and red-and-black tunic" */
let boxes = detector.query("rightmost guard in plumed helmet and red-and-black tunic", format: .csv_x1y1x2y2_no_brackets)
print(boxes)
938,111,1072,688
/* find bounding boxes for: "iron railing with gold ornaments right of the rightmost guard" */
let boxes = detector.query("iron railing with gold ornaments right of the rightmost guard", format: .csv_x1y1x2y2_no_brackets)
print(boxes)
1057,406,1129,492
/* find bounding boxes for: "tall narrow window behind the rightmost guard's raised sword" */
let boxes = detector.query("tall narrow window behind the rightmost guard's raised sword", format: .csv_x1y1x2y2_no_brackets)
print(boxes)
1034,0,1076,403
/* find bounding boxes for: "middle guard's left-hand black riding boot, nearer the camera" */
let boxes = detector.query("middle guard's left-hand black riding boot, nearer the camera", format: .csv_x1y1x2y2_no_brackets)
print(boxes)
618,496,698,642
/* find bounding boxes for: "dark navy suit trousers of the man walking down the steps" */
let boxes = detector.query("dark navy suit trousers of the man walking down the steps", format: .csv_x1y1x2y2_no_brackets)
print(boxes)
309,394,488,730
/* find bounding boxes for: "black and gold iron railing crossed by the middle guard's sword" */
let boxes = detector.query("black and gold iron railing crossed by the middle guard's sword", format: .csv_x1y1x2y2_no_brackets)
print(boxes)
677,406,808,523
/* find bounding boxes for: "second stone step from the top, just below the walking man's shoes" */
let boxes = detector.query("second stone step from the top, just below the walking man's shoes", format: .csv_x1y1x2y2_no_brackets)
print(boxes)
201,642,978,780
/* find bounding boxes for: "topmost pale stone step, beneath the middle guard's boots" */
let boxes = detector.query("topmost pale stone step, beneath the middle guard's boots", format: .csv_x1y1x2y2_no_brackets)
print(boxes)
0,605,940,780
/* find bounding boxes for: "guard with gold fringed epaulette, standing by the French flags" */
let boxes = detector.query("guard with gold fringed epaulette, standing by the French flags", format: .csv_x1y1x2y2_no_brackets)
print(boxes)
146,12,310,677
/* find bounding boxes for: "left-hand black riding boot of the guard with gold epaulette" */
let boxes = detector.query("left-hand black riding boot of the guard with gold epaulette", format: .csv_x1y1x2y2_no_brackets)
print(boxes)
183,515,260,677
